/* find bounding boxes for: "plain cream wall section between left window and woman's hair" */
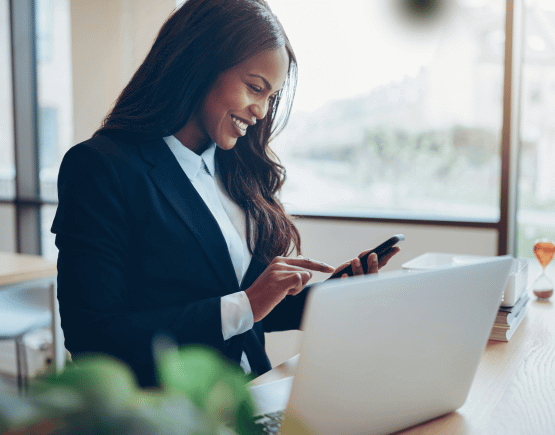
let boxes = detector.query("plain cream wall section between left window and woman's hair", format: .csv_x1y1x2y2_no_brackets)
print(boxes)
71,0,175,143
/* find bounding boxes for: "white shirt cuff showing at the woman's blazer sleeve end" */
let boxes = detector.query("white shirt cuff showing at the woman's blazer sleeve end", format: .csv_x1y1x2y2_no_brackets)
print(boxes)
221,292,254,340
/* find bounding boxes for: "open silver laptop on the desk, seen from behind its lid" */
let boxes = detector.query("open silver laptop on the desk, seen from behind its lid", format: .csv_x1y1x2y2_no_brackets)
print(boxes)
250,256,512,435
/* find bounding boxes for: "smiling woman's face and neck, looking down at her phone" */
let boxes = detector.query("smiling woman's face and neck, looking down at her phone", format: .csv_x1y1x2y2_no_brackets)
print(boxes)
176,47,289,154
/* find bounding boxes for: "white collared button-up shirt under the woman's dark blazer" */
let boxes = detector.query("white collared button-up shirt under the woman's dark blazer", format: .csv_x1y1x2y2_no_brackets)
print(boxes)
164,136,254,373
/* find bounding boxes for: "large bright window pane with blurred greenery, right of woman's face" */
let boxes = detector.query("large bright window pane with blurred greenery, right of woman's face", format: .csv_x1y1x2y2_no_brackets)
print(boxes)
271,0,505,222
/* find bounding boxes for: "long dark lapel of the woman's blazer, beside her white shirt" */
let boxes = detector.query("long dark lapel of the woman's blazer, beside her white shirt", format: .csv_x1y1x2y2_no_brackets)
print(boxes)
140,139,239,294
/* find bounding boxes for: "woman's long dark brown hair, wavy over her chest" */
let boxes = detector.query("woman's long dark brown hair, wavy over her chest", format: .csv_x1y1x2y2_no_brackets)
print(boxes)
95,0,301,263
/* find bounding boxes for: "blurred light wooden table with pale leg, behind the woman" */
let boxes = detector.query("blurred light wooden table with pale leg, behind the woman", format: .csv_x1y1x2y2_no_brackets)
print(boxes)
0,252,65,370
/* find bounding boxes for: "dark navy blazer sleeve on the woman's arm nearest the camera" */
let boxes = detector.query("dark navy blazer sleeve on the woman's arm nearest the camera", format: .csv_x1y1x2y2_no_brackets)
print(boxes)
52,145,226,378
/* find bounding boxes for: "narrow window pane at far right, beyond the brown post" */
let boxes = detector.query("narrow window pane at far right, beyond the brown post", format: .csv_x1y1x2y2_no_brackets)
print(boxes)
517,0,555,257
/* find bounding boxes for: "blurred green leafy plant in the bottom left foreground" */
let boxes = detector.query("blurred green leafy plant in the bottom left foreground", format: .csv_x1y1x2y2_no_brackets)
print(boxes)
0,346,254,435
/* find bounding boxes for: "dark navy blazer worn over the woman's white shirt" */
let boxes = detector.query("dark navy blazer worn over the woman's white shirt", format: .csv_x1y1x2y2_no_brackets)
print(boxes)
52,135,307,386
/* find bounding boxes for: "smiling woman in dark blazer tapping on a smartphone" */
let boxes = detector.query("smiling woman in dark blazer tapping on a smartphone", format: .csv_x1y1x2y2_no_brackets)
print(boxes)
52,0,398,386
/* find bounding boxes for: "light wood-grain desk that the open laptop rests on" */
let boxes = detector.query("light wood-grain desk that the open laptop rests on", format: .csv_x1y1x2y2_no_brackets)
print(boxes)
251,292,555,435
